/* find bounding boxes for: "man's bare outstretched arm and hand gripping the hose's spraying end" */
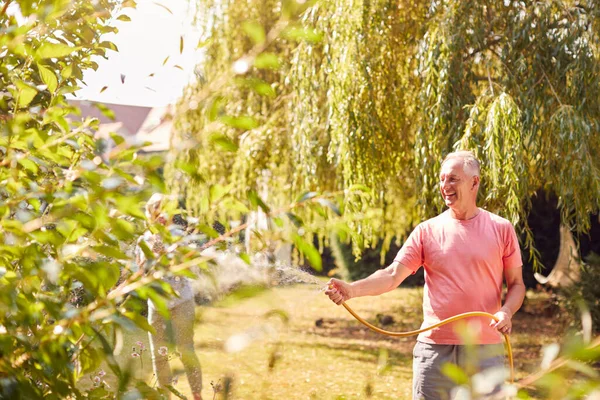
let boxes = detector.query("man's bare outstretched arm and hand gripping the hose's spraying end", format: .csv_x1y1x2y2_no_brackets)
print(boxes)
325,262,412,305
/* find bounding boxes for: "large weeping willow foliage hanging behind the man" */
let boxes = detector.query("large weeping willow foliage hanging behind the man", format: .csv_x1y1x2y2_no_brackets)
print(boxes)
167,0,600,262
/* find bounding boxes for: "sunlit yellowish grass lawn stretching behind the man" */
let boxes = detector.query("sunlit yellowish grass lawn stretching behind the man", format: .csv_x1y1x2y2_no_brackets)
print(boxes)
98,285,564,400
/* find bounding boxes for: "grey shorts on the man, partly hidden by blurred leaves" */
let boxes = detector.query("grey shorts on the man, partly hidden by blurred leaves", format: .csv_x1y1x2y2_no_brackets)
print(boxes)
413,342,504,400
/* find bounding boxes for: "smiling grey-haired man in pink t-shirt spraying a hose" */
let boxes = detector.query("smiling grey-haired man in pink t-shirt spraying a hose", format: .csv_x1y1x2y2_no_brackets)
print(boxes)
325,151,525,400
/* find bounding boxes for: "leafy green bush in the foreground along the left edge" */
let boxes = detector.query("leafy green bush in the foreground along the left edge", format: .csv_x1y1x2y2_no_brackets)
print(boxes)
0,0,196,399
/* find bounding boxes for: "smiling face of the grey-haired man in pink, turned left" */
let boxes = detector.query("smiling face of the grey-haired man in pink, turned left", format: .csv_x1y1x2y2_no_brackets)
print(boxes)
440,159,479,209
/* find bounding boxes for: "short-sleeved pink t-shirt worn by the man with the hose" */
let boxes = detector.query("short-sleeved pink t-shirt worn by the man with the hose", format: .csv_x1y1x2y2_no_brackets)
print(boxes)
394,209,522,344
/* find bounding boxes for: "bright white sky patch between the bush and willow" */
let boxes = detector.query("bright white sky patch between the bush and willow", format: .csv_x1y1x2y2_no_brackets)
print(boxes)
76,0,200,107
